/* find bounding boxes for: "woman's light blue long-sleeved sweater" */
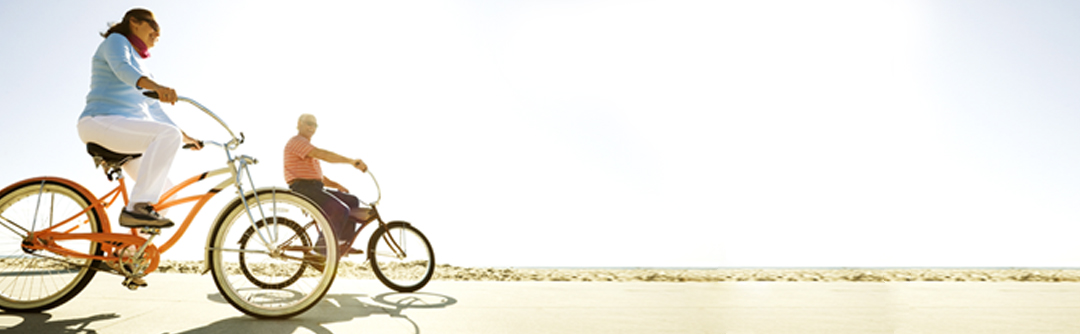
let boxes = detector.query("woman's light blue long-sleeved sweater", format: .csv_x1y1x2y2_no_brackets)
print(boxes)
79,34,176,126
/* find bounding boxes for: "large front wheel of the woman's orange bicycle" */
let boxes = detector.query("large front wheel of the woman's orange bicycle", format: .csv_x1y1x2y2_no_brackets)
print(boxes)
207,189,338,318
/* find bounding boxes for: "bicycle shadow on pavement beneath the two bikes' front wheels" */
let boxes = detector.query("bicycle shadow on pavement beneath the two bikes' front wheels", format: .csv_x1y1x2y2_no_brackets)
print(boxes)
178,292,457,334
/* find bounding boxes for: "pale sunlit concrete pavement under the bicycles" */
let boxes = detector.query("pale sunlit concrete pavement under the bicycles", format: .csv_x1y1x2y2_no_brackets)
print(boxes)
0,273,1080,334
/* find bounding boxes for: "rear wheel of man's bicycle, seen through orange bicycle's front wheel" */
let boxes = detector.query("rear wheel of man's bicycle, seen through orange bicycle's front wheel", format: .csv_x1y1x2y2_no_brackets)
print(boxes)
239,218,311,289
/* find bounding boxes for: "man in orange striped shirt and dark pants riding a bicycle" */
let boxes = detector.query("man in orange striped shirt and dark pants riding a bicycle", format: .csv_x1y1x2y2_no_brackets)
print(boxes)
284,113,372,266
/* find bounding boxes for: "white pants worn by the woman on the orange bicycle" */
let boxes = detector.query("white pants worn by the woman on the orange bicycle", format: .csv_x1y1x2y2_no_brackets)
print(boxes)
79,116,184,210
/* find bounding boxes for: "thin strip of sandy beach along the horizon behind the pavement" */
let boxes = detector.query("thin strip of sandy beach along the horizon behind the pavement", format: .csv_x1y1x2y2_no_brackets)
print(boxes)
145,260,1080,282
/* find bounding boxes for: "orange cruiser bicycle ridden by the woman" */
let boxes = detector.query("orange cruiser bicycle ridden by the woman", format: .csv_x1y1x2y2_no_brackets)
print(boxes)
0,92,338,318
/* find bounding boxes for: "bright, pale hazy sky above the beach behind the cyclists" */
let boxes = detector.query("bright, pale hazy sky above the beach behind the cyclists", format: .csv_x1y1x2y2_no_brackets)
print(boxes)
0,0,1080,267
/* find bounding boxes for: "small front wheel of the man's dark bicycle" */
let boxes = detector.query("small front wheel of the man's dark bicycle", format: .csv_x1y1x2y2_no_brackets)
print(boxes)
367,222,435,292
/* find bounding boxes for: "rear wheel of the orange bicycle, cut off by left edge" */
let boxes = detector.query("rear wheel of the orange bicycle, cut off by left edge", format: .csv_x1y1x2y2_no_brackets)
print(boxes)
0,179,102,311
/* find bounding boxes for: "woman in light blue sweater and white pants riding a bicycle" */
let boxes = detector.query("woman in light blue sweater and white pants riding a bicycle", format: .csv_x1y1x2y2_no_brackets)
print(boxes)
79,9,202,228
